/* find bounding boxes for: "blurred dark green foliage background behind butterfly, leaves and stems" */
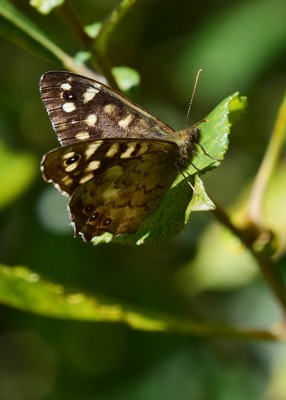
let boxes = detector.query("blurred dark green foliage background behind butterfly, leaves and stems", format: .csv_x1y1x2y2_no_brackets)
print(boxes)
0,0,286,400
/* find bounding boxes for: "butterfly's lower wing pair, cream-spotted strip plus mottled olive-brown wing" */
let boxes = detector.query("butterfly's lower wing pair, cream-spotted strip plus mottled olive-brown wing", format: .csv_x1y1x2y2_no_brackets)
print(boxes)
42,139,178,241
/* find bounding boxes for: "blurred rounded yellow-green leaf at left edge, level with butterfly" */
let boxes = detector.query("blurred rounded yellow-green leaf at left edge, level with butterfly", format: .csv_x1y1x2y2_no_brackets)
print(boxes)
0,144,38,209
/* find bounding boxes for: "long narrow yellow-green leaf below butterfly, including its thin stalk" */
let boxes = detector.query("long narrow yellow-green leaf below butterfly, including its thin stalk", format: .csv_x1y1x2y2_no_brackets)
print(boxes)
0,265,278,340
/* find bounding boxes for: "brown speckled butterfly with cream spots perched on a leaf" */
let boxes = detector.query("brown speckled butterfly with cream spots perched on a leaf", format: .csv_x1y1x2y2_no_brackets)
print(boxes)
40,71,199,241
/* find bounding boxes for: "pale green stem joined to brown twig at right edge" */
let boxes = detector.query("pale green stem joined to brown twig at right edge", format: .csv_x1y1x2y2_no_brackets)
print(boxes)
210,96,286,316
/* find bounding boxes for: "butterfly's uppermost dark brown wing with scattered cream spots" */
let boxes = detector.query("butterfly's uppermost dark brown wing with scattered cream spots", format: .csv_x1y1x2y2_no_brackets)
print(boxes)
40,72,174,145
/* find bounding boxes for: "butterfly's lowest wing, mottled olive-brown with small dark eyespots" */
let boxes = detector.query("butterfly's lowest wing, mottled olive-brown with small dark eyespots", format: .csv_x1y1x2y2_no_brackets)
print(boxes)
69,143,177,241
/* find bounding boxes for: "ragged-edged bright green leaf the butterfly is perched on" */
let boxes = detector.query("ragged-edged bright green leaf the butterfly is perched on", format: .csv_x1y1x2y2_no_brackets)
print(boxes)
92,93,246,244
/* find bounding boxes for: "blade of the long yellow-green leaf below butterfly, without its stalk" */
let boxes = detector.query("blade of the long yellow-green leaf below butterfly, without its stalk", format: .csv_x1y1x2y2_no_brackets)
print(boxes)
0,265,174,331
